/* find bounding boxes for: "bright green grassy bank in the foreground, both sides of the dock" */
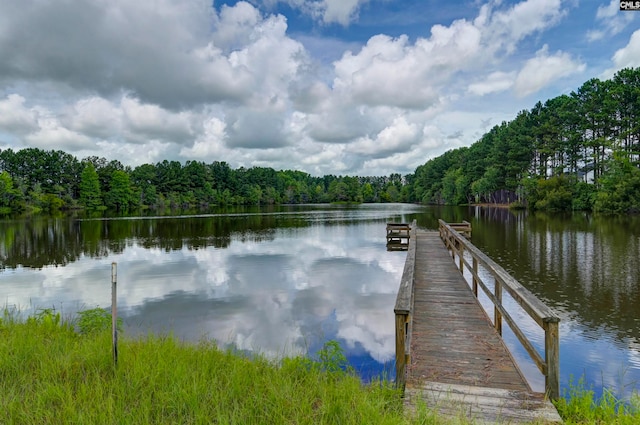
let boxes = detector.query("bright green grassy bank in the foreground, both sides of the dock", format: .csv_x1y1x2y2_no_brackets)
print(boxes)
0,311,640,424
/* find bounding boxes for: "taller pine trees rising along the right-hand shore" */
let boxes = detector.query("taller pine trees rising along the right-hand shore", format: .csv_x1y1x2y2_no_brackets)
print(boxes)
409,68,640,213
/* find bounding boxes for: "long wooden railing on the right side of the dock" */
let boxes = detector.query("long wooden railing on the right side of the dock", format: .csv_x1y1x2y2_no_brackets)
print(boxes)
438,220,560,400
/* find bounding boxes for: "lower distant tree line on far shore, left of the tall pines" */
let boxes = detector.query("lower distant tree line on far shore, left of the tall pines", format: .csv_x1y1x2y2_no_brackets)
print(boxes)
0,148,407,214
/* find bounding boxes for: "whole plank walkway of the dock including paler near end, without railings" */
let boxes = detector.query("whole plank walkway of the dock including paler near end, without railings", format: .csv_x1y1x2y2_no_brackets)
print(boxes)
396,224,562,423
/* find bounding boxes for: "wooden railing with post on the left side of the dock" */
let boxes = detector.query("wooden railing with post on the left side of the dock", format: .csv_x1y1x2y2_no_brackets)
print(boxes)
393,220,417,389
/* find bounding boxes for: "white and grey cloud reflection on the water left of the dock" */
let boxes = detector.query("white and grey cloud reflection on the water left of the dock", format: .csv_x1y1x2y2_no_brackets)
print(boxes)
0,219,405,374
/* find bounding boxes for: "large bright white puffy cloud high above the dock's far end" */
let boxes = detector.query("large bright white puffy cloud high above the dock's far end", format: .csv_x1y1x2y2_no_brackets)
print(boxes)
333,21,480,109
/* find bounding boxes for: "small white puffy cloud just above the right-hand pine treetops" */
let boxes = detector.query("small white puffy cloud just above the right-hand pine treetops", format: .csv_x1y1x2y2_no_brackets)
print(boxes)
514,45,585,97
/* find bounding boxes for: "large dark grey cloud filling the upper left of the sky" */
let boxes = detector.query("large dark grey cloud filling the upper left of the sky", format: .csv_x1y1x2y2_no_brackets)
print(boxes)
0,0,260,107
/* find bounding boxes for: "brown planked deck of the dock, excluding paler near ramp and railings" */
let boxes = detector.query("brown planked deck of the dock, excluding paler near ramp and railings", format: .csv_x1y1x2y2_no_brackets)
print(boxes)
407,231,530,391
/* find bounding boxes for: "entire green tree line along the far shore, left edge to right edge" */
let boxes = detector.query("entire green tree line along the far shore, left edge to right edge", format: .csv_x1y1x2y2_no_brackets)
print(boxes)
0,68,640,214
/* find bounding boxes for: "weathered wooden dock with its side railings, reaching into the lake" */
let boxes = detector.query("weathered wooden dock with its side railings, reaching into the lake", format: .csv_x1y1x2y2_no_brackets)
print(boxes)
395,222,562,423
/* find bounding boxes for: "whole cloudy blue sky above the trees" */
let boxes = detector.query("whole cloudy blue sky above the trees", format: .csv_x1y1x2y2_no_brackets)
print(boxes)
0,0,640,176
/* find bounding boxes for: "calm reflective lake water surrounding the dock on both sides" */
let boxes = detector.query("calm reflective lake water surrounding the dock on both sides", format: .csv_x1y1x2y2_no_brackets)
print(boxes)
0,204,640,395
